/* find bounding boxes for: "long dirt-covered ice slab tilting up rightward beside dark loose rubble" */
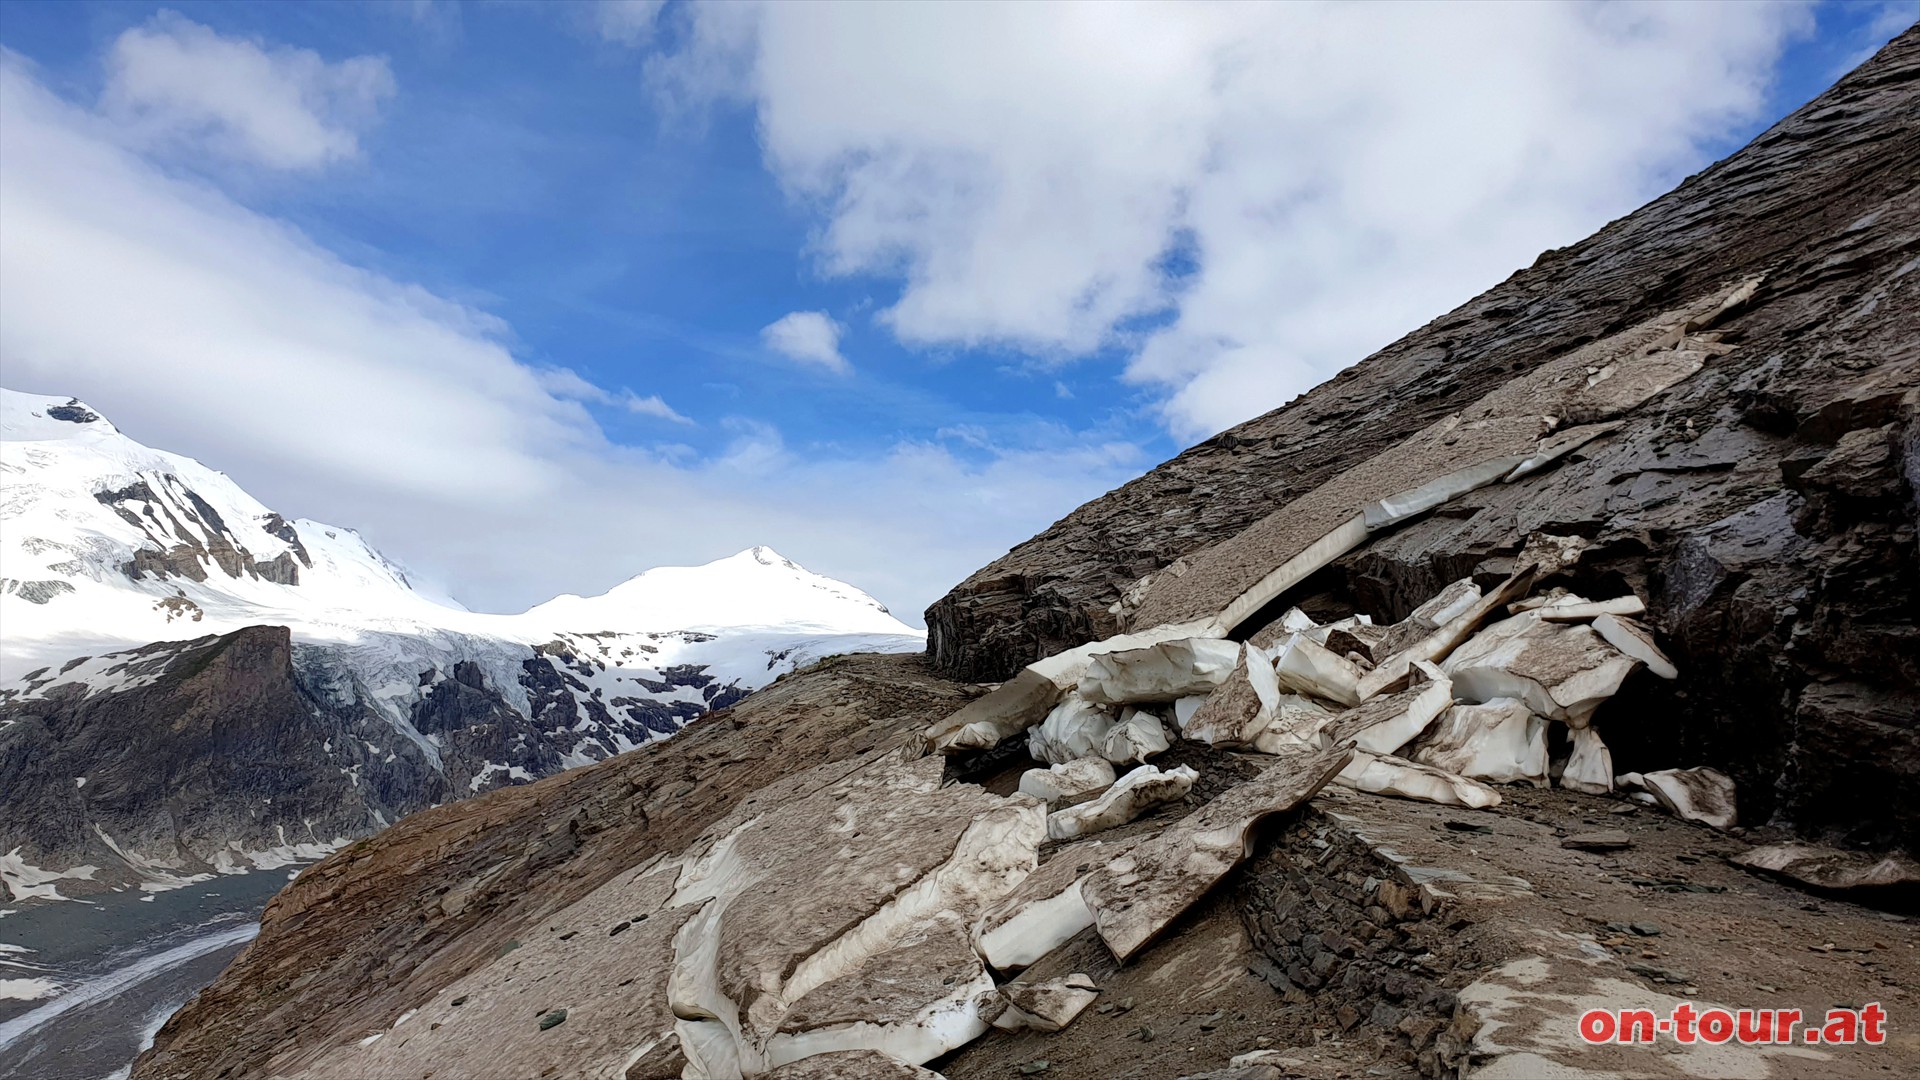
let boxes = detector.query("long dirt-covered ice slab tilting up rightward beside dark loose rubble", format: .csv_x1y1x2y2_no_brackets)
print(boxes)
1081,746,1352,961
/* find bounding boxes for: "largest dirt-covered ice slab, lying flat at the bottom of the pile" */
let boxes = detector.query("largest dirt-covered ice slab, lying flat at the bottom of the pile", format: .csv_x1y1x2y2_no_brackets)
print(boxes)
666,753,1046,1076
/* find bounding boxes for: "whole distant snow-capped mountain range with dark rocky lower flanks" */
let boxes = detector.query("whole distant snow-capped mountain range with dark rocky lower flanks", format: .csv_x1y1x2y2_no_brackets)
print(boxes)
0,392,922,897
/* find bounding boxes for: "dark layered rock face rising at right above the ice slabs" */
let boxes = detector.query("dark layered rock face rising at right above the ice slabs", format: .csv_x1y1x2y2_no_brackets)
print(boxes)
927,31,1920,846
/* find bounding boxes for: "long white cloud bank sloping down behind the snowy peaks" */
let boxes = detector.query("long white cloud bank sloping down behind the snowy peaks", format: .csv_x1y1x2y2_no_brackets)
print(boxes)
0,54,1121,621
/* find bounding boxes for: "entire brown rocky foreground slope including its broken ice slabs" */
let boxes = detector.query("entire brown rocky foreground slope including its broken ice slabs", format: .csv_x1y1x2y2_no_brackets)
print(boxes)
134,23,1920,1080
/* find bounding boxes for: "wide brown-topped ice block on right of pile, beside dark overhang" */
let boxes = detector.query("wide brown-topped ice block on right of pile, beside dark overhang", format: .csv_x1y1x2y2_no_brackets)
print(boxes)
1444,611,1640,728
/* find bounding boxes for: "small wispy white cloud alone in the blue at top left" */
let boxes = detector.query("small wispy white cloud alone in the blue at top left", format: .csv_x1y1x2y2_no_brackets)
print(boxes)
100,12,394,169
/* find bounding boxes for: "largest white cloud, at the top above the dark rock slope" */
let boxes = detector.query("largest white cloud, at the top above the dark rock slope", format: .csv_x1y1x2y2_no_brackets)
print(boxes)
653,0,1811,436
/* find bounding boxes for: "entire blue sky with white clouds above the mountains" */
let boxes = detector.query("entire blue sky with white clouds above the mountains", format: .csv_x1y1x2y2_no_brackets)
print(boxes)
0,0,1916,619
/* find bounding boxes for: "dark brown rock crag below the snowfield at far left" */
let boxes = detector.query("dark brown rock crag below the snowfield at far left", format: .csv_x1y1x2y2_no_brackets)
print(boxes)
0,626,449,880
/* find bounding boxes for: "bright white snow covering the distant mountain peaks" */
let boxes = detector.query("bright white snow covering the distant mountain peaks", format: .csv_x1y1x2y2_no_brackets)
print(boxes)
0,390,925,749
